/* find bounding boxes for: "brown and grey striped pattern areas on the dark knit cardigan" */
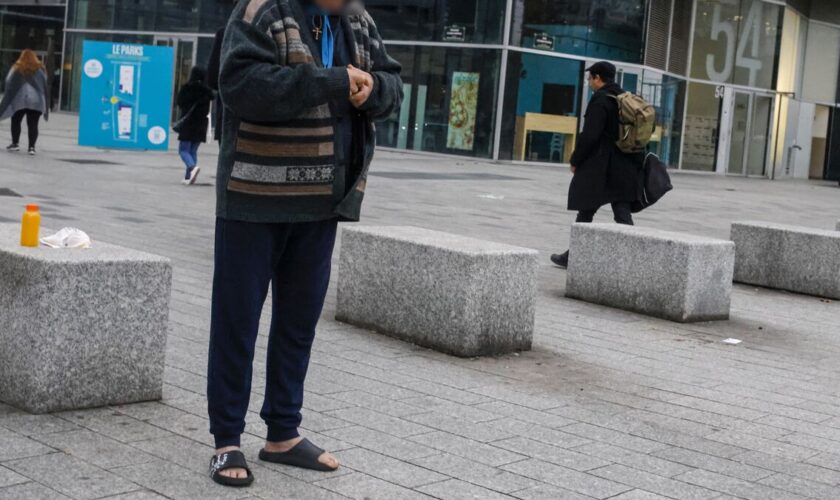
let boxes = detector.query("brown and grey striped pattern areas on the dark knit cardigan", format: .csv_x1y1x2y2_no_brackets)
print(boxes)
228,0,372,196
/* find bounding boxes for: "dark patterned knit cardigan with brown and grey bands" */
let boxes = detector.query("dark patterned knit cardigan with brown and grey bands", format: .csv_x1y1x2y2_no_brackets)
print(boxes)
218,0,402,222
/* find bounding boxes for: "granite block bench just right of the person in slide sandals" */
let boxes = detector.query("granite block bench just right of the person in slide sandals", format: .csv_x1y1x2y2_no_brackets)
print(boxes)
336,226,538,357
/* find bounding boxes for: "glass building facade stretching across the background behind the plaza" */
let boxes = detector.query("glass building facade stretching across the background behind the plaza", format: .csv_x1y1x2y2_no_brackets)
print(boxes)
0,0,840,177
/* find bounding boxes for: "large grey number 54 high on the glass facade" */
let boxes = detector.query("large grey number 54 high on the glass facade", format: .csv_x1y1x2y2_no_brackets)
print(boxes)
706,0,764,86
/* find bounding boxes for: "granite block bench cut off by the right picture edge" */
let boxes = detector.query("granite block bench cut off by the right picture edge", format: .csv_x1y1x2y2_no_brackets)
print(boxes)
732,222,840,299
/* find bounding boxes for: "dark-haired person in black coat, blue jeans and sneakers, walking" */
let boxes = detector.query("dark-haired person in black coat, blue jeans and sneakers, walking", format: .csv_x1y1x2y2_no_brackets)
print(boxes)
175,66,213,184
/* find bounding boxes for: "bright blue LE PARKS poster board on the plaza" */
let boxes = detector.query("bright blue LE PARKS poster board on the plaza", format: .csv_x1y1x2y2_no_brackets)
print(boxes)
79,40,174,150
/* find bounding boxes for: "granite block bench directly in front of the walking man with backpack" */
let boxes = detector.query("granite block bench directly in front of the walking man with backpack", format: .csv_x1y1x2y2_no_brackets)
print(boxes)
566,224,735,323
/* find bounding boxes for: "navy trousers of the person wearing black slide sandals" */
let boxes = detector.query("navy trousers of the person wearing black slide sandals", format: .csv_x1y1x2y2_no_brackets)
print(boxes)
207,219,337,448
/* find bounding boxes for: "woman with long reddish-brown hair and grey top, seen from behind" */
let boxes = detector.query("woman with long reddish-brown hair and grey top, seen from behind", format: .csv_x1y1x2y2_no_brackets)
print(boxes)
0,49,50,155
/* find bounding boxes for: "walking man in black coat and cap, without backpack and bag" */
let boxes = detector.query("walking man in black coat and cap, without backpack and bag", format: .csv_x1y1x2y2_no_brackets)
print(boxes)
551,61,644,268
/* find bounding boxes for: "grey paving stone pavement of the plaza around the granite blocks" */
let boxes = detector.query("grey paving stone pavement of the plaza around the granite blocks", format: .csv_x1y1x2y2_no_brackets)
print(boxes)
0,114,840,500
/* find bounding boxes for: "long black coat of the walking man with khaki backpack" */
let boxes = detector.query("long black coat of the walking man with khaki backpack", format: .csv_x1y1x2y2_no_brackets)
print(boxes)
569,83,644,211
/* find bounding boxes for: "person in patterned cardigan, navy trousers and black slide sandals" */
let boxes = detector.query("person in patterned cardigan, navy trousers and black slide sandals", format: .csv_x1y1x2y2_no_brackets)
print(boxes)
207,0,402,486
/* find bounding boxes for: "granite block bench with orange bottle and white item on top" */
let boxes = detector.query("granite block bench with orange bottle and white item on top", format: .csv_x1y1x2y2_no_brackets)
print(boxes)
0,224,172,413
